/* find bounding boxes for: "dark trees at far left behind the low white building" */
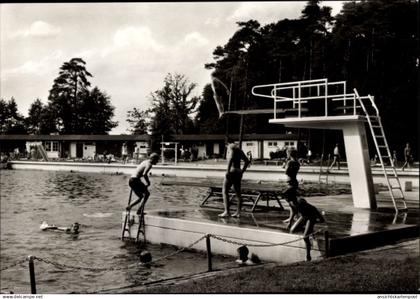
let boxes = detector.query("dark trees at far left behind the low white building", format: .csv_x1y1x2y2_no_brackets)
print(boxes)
0,58,117,134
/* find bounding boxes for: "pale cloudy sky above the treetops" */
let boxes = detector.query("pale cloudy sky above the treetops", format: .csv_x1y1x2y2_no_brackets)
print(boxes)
0,1,342,134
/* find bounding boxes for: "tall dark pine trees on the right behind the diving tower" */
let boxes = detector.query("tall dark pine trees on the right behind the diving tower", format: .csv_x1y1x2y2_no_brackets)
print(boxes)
197,0,419,158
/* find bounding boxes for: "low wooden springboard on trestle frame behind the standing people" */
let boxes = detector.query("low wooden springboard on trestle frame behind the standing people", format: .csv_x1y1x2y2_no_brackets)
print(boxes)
162,180,284,213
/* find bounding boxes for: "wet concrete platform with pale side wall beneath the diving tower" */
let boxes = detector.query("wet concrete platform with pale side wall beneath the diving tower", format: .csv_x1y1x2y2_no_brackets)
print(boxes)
123,191,419,263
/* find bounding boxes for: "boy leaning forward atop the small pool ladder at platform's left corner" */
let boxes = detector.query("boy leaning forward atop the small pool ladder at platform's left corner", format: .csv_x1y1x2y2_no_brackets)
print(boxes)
126,153,159,215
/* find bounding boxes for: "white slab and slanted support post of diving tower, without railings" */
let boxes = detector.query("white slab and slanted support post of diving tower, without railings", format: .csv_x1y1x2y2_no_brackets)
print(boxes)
270,115,377,209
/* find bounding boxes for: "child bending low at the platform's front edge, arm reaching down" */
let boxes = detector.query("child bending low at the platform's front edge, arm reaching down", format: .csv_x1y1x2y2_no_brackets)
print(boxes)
290,198,325,261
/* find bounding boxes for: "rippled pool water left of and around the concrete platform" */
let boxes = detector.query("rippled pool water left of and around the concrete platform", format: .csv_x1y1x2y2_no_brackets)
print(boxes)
0,170,231,293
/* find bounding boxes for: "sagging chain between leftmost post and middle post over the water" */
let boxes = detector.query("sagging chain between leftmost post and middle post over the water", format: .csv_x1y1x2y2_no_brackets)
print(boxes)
30,236,206,271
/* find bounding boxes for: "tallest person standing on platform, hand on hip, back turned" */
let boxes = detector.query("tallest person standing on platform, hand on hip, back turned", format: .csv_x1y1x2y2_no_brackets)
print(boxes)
219,139,250,217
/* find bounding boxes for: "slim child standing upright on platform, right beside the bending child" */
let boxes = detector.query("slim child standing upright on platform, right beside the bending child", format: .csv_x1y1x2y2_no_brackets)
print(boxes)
283,149,300,230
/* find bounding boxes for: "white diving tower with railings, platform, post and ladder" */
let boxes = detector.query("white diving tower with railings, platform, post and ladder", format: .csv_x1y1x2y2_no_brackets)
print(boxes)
252,79,407,212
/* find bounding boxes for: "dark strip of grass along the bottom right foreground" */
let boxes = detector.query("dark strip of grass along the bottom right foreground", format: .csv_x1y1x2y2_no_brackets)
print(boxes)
139,239,420,294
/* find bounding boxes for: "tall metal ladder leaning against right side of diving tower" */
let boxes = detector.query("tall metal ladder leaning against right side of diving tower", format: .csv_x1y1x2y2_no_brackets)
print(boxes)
353,89,407,213
